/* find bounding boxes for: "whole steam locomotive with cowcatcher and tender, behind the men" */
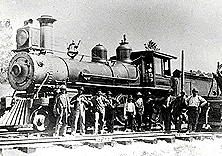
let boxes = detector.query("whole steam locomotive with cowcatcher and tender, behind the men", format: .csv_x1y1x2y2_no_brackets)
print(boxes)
0,15,220,131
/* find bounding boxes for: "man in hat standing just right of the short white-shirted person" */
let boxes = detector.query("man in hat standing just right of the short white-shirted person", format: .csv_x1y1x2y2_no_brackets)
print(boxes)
135,92,144,131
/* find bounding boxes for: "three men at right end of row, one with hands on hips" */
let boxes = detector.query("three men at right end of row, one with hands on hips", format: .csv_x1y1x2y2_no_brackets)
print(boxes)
162,88,207,133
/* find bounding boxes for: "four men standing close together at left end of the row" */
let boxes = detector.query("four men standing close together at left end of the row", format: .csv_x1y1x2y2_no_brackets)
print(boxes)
53,85,118,136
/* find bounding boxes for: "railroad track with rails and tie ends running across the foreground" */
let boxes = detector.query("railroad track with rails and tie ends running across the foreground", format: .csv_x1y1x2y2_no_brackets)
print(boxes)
0,132,222,153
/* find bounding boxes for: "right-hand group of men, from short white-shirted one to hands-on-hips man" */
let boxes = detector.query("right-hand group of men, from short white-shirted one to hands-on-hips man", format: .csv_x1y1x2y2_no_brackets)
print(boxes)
124,88,207,133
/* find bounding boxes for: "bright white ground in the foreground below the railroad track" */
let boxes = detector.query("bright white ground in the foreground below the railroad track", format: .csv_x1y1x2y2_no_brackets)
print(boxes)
2,139,222,156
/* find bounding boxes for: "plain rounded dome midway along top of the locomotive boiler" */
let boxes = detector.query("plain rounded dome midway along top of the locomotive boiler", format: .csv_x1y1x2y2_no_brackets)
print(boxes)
92,44,107,63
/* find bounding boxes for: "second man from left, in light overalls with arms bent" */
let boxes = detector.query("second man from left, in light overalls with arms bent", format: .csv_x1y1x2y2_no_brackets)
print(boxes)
70,87,88,136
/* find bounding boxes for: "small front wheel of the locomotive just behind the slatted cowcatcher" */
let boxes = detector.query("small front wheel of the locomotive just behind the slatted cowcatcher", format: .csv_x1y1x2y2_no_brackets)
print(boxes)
31,110,50,132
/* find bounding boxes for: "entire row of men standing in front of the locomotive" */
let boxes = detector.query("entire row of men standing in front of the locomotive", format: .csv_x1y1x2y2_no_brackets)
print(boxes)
53,85,207,136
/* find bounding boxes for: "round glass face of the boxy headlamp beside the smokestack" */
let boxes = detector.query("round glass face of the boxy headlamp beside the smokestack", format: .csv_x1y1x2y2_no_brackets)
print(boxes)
16,29,29,47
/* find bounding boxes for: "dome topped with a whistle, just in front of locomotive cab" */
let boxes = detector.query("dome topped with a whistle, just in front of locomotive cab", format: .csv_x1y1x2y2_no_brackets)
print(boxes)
116,35,132,63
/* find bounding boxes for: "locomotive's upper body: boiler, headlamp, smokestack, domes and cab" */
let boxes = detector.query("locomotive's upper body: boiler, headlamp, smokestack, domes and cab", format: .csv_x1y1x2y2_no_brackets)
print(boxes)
8,15,176,92
